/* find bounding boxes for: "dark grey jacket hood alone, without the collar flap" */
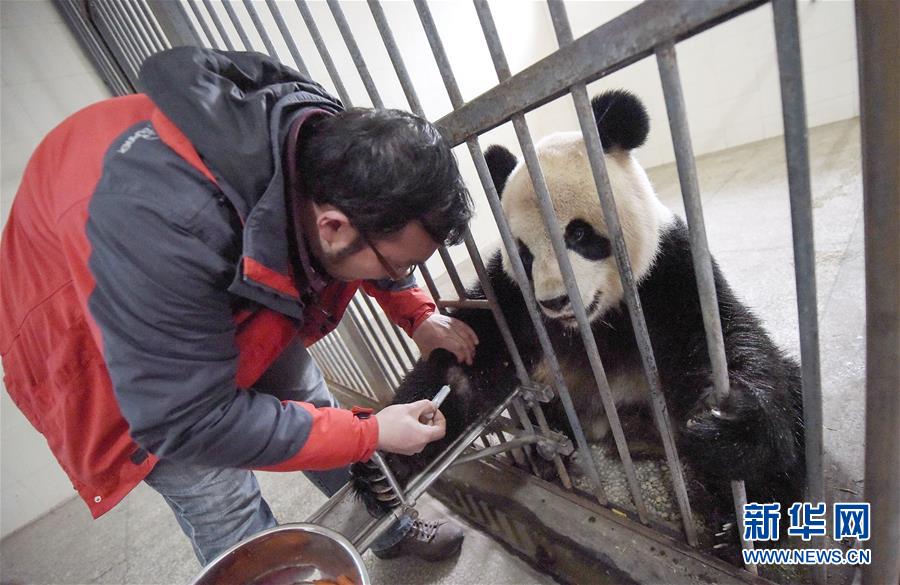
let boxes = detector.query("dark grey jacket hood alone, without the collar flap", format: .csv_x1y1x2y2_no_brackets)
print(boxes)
140,47,343,217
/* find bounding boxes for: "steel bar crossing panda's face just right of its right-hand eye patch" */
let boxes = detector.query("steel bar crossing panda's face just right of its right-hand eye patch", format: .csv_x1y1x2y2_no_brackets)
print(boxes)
548,0,697,546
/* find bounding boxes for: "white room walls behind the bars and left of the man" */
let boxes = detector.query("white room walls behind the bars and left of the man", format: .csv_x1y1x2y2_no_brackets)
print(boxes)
0,0,858,535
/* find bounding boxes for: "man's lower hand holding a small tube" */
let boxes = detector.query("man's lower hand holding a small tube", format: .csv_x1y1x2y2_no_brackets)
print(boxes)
375,400,447,455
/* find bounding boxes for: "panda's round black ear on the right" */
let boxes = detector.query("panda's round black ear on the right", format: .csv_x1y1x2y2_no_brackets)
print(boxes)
591,89,650,151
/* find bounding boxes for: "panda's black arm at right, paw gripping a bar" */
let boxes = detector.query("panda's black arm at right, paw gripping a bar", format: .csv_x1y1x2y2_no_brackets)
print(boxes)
674,264,804,501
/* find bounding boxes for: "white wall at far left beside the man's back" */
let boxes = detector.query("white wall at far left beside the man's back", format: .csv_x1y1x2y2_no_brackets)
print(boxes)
0,0,109,536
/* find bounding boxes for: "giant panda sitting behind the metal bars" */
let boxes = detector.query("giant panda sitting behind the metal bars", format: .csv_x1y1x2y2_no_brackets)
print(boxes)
353,90,805,556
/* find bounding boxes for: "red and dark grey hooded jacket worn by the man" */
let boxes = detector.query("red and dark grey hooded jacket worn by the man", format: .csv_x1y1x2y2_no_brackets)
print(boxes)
0,47,434,517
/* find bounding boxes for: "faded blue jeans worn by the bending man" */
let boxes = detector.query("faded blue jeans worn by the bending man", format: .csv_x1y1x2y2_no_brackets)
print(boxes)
144,341,412,565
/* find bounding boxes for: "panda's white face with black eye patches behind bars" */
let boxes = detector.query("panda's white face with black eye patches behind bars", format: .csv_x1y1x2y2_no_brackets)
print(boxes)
502,132,672,327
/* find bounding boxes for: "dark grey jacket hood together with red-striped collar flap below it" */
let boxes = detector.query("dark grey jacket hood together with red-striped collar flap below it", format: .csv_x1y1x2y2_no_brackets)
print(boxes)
140,47,343,317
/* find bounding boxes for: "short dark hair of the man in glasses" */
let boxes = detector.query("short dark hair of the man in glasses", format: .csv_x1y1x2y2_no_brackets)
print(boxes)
297,108,472,245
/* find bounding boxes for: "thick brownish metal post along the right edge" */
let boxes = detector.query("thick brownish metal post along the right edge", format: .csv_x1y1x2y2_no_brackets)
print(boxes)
856,0,900,585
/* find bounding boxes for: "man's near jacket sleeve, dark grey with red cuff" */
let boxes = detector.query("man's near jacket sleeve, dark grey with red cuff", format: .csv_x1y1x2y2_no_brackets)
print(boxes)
86,187,378,471
